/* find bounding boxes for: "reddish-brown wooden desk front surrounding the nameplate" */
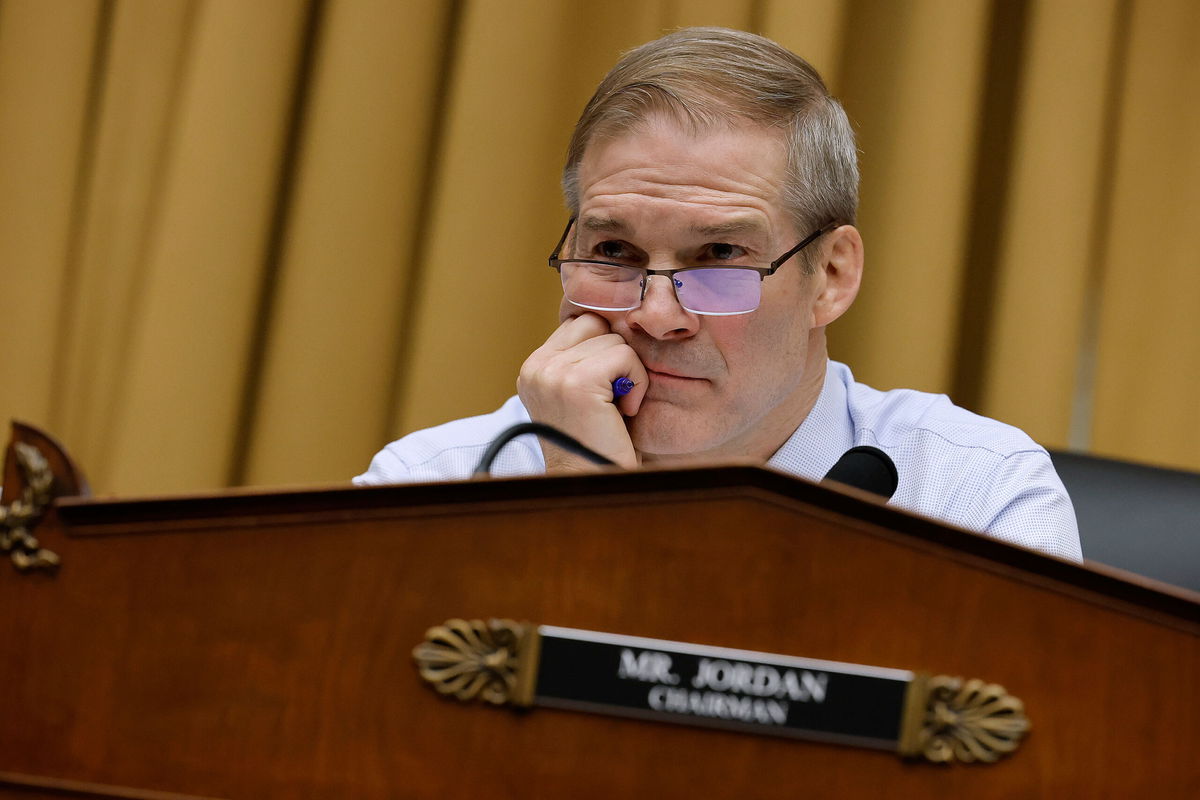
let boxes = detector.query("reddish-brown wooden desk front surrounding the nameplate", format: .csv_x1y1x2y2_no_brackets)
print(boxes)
0,468,1200,800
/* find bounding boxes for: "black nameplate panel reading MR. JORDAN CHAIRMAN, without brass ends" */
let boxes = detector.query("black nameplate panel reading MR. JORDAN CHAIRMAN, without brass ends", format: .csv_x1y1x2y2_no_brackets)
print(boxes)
534,625,913,750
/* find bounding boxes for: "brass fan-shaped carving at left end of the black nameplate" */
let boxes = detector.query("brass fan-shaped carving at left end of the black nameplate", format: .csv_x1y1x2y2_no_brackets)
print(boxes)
413,619,538,705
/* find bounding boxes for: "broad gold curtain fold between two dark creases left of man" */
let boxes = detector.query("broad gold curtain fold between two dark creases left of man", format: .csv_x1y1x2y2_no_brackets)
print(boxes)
242,0,454,483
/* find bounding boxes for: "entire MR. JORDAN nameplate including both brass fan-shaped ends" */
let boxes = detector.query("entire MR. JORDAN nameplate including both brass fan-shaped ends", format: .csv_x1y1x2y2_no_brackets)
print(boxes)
413,619,1030,763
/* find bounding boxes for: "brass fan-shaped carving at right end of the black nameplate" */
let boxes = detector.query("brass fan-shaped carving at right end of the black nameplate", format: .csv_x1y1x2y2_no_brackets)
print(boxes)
900,675,1030,764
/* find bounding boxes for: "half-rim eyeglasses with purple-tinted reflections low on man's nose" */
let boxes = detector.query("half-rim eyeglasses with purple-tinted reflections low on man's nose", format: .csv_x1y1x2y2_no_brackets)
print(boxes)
550,217,839,317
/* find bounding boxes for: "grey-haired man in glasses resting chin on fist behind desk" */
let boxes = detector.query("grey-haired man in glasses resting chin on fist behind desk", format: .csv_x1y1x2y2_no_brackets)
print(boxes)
358,29,1080,559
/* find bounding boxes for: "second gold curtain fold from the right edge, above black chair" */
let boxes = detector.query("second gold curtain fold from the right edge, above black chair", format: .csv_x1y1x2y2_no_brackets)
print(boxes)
979,0,1124,447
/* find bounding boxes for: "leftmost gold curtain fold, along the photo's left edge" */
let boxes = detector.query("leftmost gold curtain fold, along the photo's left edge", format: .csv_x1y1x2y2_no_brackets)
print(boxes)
0,0,103,448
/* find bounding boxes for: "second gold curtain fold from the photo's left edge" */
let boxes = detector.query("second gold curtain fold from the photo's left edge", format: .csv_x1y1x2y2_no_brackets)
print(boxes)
52,2,196,482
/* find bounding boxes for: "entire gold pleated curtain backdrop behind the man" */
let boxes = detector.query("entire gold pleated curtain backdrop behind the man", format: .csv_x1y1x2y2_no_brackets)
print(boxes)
0,0,1200,494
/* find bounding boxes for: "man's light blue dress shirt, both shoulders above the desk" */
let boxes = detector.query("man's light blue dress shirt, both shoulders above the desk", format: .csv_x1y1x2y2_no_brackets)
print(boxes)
354,361,1081,561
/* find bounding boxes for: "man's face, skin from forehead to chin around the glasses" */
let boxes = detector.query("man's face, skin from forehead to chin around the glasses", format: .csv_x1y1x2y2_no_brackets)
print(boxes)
560,116,824,461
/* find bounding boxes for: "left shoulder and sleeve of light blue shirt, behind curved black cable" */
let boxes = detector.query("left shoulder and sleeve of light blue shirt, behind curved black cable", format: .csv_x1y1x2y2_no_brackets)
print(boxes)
354,396,545,486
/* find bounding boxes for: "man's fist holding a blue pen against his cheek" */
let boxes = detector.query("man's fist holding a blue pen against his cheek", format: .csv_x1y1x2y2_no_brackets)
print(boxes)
517,313,648,471
